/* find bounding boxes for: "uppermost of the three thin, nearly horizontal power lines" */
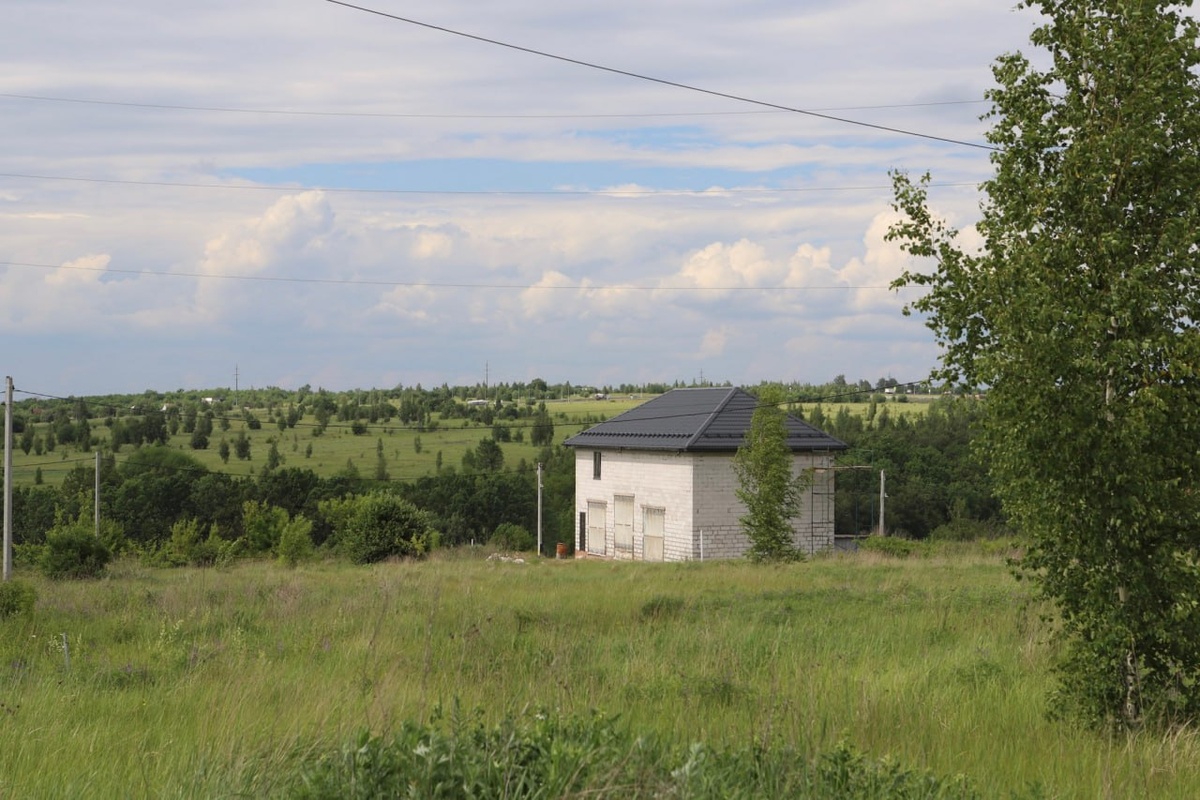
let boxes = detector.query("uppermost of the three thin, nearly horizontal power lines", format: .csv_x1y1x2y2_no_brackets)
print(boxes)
0,92,988,120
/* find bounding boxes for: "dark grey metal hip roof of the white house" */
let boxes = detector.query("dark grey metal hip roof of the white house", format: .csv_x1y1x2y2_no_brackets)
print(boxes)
563,387,846,452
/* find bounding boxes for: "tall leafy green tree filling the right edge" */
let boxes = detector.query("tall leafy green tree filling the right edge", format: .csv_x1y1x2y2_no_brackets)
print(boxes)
889,0,1200,727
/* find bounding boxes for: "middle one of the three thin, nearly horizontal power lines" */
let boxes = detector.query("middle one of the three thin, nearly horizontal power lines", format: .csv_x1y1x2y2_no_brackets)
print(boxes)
0,173,978,198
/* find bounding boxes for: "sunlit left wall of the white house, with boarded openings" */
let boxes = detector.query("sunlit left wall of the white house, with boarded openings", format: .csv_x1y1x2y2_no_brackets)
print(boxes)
575,447,692,561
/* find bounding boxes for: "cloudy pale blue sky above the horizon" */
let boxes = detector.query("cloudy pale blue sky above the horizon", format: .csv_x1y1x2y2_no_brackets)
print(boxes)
0,0,1039,396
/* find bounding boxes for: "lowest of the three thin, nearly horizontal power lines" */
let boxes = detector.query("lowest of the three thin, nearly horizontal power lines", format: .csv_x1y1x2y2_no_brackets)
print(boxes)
0,261,892,293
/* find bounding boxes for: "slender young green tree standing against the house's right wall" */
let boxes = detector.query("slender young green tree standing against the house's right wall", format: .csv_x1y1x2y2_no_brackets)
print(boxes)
733,390,804,561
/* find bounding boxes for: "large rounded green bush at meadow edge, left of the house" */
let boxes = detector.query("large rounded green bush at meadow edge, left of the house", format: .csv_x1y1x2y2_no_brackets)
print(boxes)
323,492,438,564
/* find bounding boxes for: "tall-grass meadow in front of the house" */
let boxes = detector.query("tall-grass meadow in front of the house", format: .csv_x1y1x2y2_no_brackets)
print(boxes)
0,549,1200,798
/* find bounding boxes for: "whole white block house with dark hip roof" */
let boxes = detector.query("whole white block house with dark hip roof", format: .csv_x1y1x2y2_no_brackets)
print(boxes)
564,387,846,561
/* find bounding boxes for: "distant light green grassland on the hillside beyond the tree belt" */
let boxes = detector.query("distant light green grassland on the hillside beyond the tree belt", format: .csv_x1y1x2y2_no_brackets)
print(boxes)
13,396,928,486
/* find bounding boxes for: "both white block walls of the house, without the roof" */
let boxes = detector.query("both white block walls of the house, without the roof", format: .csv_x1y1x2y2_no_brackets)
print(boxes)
575,447,834,561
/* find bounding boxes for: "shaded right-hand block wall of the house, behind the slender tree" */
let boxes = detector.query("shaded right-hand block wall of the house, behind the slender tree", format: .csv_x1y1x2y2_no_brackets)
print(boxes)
690,452,834,560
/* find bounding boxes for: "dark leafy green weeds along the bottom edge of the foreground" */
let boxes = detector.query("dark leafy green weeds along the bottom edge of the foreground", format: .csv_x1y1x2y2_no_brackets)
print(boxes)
284,708,978,800
